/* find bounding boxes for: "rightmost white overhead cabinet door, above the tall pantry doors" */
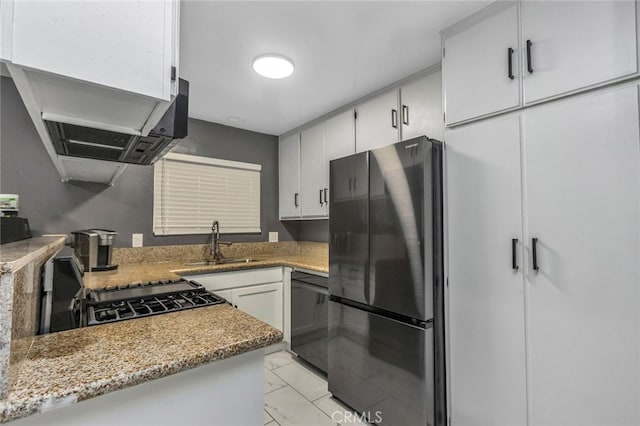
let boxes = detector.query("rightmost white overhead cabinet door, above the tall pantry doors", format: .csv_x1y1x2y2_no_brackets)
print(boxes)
524,1,638,103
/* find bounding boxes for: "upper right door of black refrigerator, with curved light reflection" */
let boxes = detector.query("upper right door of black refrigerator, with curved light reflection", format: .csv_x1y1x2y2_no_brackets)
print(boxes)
369,137,439,320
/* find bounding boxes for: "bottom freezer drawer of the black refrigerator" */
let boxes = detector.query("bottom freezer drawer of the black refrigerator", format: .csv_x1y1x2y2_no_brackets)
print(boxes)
329,301,434,426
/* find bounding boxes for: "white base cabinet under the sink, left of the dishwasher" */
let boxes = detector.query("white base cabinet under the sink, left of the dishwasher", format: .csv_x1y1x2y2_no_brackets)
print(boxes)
185,267,284,331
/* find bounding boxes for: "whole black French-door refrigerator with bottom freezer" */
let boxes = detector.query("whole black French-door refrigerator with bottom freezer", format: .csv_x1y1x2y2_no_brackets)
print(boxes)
328,137,446,426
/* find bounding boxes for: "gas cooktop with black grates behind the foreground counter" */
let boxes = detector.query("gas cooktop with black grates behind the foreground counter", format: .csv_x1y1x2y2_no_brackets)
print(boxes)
86,280,226,325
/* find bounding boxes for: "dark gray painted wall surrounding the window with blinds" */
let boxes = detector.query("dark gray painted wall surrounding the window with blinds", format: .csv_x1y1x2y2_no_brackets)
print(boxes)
0,77,296,247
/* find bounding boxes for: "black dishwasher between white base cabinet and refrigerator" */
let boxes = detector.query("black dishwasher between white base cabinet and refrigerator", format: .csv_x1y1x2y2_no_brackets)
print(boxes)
291,270,329,374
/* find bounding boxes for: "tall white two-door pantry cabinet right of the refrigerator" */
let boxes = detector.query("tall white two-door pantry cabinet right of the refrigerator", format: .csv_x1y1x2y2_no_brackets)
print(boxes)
446,86,640,426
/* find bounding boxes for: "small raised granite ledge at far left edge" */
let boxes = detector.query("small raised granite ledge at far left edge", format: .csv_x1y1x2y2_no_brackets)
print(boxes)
0,236,65,273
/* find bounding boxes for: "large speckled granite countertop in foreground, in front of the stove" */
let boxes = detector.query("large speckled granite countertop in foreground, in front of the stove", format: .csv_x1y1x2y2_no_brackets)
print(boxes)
0,304,282,423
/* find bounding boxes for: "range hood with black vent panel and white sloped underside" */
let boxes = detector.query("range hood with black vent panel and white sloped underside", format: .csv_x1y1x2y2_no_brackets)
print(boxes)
5,62,189,185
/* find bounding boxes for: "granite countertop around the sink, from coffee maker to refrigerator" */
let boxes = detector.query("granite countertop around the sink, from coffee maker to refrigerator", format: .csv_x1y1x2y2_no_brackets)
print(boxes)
84,254,329,288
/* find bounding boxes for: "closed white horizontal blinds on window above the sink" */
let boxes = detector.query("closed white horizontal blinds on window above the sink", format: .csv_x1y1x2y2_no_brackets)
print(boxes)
153,153,262,235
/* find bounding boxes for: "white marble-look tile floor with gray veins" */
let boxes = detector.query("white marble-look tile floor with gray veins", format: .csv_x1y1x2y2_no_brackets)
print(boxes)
264,351,366,426
